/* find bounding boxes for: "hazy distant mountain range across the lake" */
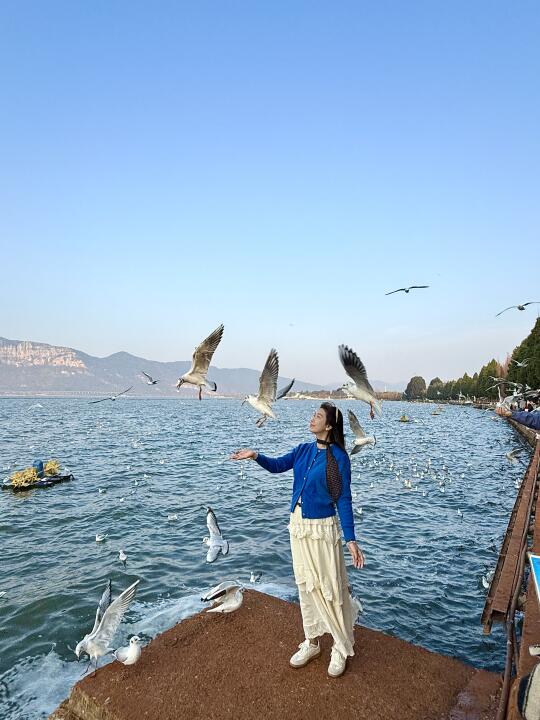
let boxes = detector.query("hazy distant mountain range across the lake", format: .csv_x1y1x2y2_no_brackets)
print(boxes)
0,337,405,397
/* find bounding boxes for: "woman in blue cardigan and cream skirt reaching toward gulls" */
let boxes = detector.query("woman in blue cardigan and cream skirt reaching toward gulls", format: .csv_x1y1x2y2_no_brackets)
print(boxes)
231,402,364,677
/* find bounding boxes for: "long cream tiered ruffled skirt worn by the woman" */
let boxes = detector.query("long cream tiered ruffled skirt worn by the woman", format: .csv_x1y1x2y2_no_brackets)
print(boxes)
289,505,360,657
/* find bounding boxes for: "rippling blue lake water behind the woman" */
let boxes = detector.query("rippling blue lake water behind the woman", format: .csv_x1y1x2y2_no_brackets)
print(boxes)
0,397,528,720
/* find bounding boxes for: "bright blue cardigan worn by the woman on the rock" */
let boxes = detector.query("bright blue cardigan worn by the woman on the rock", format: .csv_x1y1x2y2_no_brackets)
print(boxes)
255,442,355,542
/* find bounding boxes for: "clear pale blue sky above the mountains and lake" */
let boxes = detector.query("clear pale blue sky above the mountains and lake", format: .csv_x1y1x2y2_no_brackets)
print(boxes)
0,0,540,384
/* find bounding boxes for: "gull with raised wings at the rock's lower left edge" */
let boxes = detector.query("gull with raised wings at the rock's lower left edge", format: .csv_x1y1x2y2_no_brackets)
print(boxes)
75,580,140,672
